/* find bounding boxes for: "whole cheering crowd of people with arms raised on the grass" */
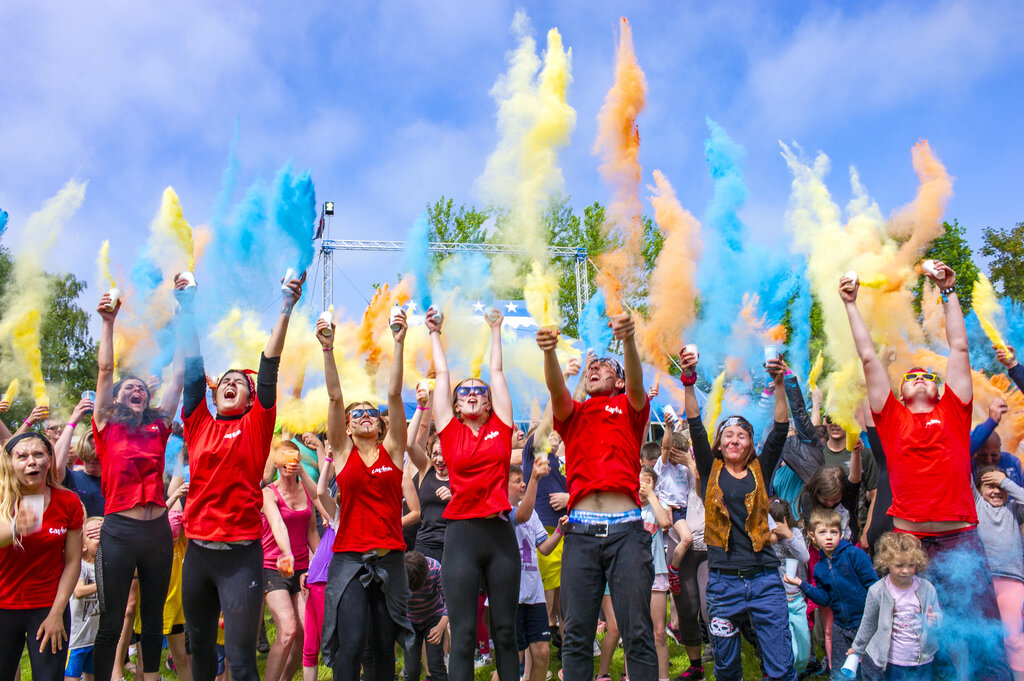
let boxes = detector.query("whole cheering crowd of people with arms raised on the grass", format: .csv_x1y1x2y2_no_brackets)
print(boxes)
0,263,1024,681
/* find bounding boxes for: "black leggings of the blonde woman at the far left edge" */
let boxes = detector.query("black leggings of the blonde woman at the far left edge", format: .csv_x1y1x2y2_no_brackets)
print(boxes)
0,607,71,681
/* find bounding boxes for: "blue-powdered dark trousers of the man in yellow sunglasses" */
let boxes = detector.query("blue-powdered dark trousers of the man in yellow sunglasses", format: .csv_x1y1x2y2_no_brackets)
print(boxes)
921,528,1011,681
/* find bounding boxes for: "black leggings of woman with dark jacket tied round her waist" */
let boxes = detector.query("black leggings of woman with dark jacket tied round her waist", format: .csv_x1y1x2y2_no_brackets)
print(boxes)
332,554,399,681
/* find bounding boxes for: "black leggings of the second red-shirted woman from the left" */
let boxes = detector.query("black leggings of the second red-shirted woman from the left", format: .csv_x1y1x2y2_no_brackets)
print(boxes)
92,513,174,681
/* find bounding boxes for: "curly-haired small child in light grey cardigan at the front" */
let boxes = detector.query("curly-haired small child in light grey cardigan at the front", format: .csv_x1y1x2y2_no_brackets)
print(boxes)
847,533,937,681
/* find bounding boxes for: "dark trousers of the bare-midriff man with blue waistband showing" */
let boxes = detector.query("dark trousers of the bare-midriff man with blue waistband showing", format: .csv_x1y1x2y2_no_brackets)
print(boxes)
560,522,658,681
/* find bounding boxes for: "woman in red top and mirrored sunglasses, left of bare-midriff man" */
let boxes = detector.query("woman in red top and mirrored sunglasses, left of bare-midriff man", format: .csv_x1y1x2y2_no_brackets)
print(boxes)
427,309,520,681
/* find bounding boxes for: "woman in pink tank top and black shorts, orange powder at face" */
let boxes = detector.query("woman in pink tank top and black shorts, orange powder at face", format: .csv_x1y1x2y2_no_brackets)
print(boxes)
261,441,319,681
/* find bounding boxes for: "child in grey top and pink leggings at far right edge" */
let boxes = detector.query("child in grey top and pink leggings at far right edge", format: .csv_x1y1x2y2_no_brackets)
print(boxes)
974,466,1024,681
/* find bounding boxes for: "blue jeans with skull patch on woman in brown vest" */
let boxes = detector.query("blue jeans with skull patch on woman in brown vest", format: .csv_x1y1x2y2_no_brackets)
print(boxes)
704,568,797,681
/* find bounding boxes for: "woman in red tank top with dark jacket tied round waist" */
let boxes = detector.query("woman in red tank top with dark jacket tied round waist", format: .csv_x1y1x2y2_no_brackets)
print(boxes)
316,313,413,681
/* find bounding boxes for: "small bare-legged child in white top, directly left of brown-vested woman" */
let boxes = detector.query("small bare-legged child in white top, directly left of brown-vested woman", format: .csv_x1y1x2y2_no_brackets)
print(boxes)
654,430,693,594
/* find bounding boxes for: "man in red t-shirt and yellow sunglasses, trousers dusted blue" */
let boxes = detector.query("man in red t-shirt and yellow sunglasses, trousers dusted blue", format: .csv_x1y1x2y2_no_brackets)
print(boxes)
840,261,1010,680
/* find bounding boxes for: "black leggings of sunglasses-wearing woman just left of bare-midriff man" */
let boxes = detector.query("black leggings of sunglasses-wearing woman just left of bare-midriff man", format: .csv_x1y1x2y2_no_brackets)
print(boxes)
441,518,520,681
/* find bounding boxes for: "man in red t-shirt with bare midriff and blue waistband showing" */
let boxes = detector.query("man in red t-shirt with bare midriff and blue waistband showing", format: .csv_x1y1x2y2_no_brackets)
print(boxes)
537,314,658,681
